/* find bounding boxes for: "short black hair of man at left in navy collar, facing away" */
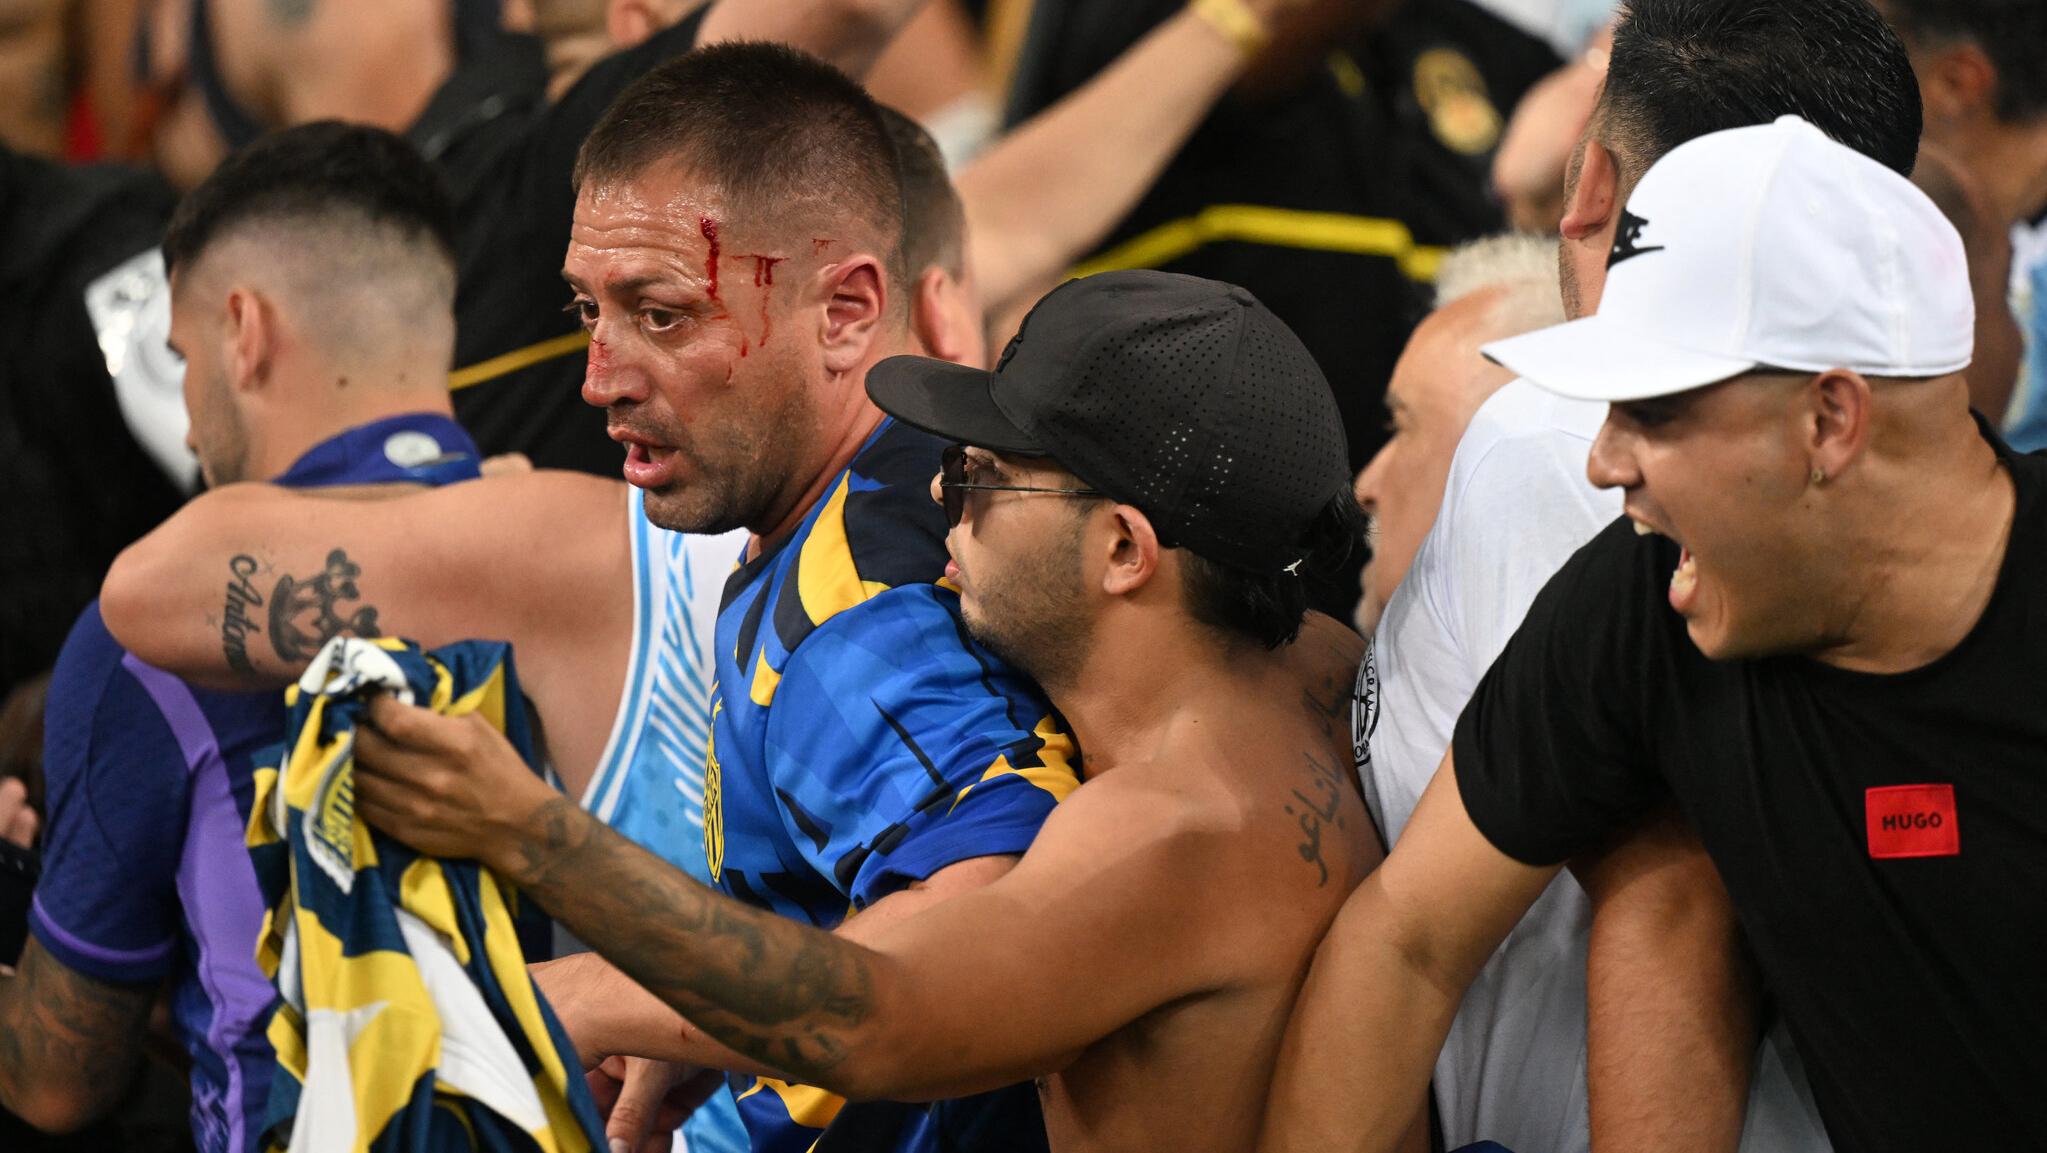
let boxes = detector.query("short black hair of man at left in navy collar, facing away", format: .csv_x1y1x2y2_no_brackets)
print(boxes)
164,121,454,285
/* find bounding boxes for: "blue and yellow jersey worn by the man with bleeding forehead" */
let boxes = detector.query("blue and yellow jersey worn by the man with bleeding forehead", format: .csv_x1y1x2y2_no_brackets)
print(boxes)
704,422,1079,1153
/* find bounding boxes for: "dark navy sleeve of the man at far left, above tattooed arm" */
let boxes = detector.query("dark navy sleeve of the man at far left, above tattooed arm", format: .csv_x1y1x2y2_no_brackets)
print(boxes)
29,604,188,983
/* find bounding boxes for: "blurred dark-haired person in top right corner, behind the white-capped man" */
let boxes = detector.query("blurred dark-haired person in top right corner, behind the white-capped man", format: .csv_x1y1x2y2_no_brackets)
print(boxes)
1881,0,2047,453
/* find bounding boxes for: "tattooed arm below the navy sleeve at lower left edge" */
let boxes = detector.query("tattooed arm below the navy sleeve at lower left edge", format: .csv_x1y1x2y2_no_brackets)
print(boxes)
0,938,156,1114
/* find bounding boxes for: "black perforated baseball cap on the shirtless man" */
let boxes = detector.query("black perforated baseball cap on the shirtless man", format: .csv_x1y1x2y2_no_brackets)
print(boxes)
868,270,1351,571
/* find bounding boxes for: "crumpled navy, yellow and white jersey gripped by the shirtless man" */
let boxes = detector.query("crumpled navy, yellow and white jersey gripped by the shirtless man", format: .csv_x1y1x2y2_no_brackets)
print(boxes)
248,637,604,1153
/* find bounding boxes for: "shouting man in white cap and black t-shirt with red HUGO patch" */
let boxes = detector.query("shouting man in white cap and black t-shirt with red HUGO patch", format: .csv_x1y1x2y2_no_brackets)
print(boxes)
1265,119,2047,1151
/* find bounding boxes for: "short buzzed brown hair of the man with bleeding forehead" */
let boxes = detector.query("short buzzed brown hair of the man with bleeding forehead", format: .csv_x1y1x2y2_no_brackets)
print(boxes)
575,41,905,283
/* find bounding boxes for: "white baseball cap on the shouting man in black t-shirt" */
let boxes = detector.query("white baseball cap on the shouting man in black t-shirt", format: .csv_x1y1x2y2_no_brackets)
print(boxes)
1484,117,1975,401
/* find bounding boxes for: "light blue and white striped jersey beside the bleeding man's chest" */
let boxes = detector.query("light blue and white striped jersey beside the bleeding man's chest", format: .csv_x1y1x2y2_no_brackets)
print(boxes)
583,489,747,1153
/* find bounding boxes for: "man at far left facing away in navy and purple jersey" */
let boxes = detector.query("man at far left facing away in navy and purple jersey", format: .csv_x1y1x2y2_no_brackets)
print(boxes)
0,123,491,1153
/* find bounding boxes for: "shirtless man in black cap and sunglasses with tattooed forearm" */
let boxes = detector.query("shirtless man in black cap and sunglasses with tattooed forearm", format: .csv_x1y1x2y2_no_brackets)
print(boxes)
339,272,1421,1153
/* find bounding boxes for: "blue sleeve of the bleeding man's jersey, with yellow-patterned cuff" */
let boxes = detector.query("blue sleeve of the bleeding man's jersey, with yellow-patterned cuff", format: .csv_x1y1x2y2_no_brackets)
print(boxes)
768,584,1079,907
